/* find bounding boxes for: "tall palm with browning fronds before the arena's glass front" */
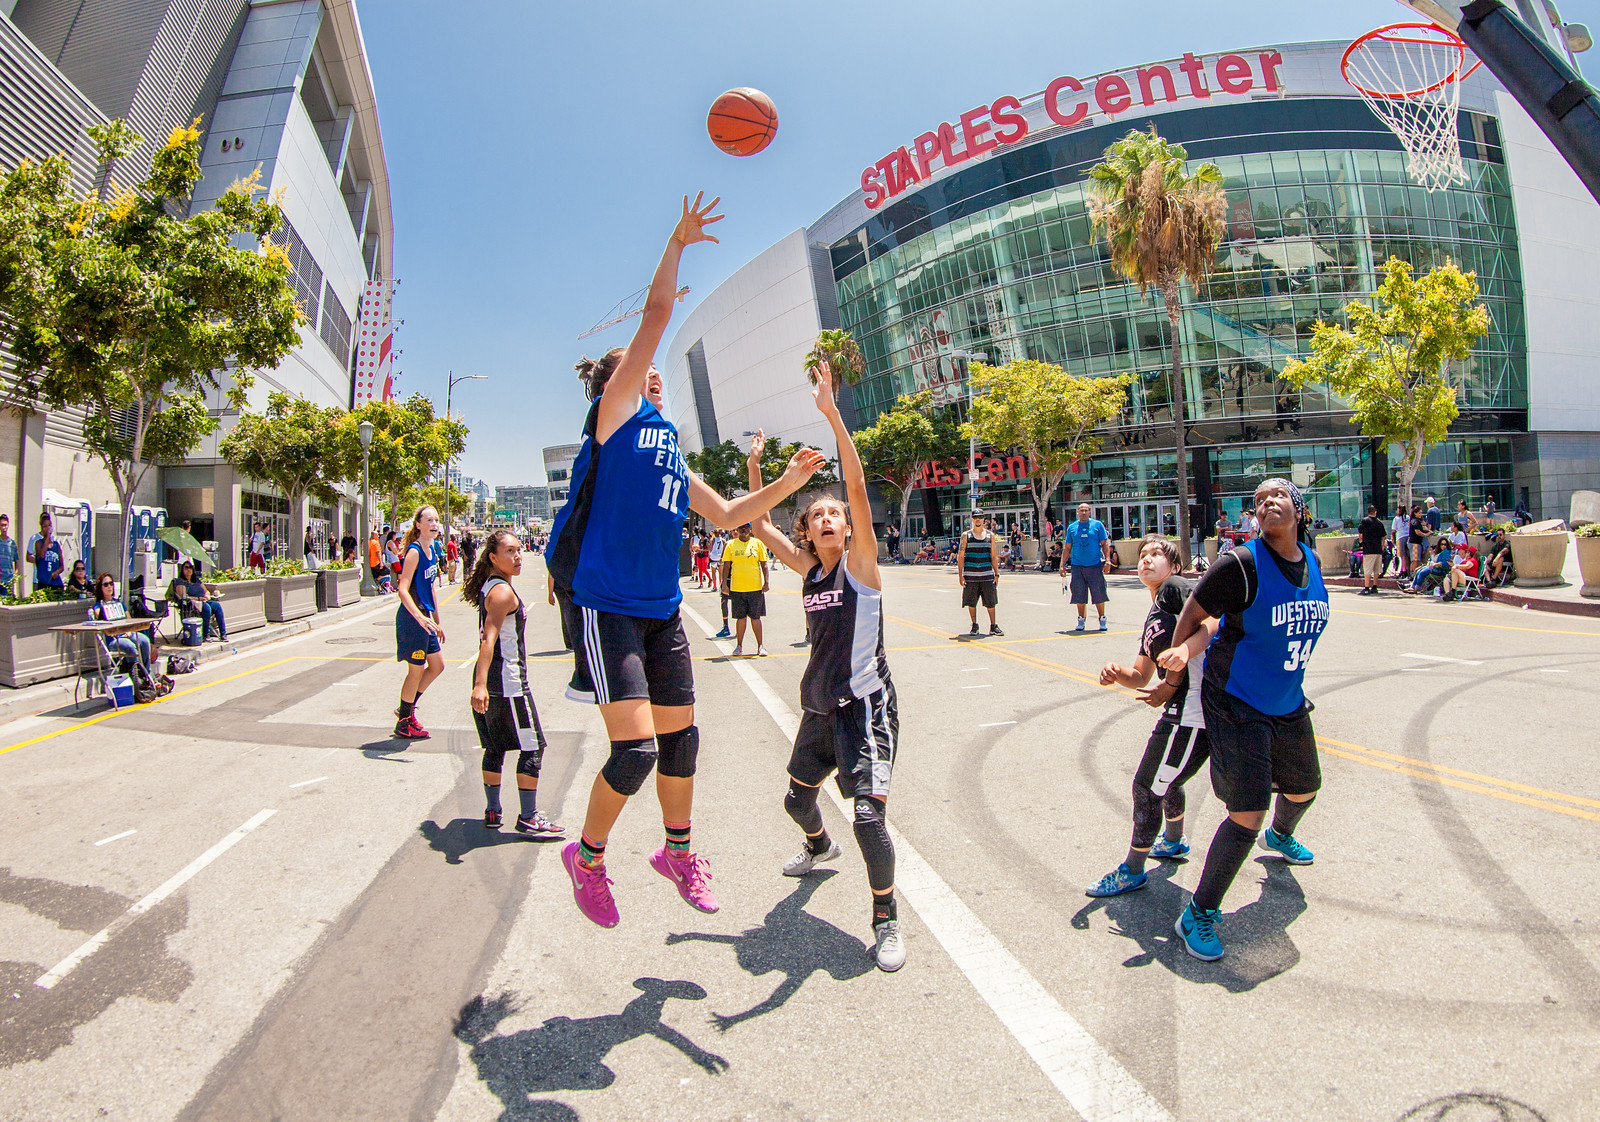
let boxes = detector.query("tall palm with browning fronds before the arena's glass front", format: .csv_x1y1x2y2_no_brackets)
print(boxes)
1090,123,1226,565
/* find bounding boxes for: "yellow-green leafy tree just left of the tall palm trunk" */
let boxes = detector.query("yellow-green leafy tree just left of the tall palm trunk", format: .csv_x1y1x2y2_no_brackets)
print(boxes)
962,359,1133,544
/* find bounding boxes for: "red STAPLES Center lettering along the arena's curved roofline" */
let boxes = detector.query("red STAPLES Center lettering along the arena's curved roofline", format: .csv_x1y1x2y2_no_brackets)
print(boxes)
861,51,1283,210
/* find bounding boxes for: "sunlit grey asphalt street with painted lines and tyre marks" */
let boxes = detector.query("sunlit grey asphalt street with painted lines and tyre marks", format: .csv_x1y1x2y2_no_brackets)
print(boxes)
0,559,1600,1122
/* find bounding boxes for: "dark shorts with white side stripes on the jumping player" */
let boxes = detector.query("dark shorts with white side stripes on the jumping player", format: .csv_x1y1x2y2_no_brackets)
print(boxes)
562,599,694,706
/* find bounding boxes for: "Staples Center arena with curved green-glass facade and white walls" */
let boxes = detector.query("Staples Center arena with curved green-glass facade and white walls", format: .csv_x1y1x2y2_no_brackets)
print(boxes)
667,32,1600,536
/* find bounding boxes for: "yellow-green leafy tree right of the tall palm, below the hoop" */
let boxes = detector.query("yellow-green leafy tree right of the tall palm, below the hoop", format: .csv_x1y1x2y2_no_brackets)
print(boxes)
1283,258,1490,507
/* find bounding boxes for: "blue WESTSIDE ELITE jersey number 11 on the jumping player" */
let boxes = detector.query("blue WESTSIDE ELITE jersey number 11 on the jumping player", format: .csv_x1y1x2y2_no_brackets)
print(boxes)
549,400,690,619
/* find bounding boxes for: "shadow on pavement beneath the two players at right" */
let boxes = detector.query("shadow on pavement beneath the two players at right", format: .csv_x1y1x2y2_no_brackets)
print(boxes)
1072,860,1306,994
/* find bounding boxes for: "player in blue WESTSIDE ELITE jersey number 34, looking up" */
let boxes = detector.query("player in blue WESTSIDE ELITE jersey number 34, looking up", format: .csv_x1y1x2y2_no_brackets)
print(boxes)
1155,479,1328,962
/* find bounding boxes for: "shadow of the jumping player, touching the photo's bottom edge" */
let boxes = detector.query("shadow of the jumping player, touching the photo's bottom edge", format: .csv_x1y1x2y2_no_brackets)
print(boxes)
454,978,728,1122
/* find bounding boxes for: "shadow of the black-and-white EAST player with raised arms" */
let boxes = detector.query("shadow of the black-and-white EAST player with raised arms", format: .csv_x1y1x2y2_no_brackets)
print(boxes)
667,869,872,1032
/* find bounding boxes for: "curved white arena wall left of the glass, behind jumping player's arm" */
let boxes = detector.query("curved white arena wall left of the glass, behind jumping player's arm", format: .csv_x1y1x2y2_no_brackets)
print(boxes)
667,230,837,456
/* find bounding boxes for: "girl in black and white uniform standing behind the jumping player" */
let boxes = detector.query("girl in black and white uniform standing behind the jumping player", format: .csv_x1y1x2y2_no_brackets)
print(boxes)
461,530,563,837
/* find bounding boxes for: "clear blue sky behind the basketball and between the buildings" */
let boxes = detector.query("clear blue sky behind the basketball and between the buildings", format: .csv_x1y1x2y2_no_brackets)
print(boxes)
358,0,1408,483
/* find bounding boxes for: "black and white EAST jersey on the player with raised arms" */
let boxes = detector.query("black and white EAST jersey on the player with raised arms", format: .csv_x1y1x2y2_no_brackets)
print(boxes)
800,557,890,712
